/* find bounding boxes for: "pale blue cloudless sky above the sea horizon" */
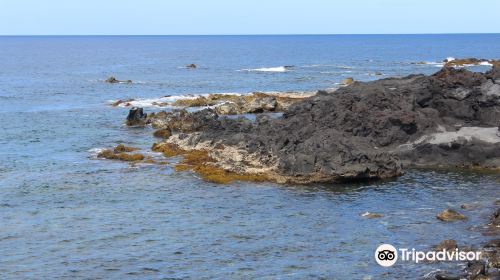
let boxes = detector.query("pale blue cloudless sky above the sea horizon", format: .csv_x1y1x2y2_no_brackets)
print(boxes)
0,0,500,35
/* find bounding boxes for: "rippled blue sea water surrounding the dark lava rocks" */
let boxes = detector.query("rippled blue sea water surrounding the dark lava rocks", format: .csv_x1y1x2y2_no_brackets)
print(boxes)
0,34,500,279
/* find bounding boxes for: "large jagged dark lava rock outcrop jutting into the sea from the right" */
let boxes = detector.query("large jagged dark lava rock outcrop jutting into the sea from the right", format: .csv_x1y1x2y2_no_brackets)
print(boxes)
139,67,500,183
